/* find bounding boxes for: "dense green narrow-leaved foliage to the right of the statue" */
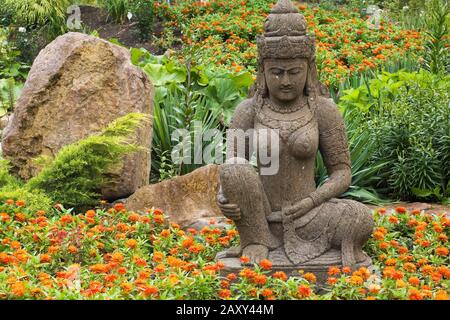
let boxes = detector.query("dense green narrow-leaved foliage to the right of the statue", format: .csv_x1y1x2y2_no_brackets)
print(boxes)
341,70,450,202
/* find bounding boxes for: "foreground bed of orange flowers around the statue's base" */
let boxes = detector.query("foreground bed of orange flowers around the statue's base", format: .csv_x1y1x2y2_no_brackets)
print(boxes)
0,199,450,299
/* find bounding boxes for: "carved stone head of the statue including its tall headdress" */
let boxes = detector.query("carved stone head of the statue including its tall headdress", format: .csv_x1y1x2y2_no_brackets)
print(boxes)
255,0,326,103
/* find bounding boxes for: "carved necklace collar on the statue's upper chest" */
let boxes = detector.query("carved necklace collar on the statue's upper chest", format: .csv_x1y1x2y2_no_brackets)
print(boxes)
256,99,315,142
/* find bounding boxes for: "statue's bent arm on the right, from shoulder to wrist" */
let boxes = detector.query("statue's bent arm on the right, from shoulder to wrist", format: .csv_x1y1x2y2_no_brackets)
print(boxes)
309,98,352,206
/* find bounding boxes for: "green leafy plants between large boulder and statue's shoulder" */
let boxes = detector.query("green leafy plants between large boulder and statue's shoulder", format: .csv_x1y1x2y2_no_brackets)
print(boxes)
132,49,253,180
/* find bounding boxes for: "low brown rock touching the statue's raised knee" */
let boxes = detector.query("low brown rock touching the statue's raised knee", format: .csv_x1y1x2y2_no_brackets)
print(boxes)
125,164,223,228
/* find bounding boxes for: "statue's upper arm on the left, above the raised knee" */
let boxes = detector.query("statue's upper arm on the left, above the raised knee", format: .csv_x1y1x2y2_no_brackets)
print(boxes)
227,99,255,161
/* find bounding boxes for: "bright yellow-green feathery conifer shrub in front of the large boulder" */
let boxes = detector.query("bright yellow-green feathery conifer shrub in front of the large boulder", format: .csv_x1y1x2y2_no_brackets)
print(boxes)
0,113,148,210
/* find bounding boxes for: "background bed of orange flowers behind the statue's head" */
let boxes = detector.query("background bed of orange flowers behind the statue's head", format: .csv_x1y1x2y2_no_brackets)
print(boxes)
155,0,423,85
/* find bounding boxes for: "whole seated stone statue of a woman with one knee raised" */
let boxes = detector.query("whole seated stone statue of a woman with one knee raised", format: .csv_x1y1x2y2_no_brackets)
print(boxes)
217,0,374,273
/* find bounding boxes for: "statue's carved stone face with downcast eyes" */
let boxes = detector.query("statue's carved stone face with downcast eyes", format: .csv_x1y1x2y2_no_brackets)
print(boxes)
264,58,308,103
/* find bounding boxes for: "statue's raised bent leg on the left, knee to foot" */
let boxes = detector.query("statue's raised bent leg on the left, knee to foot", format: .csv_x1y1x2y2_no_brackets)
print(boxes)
220,158,281,249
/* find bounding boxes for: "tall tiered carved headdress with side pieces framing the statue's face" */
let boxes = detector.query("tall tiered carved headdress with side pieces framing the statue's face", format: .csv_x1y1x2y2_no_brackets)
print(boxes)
251,0,328,98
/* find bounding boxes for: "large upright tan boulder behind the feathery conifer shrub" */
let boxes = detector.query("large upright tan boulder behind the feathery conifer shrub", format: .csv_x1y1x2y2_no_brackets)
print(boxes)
2,32,154,199
